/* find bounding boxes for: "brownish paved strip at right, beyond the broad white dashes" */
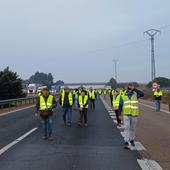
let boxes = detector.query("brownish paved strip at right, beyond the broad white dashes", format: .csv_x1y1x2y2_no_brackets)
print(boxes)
137,103,170,170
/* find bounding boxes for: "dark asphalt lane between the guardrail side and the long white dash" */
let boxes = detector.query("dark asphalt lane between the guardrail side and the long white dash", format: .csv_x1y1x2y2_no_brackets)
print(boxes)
0,108,38,148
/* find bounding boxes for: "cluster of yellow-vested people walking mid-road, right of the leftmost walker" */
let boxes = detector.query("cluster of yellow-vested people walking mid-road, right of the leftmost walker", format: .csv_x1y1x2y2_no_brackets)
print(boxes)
59,87,97,127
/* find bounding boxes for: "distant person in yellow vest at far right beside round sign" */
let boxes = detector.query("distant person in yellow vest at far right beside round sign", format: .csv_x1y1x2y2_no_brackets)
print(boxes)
154,87,163,112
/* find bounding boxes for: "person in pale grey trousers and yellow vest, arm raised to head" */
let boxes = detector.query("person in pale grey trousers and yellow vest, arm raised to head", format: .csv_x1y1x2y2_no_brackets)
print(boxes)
120,83,144,149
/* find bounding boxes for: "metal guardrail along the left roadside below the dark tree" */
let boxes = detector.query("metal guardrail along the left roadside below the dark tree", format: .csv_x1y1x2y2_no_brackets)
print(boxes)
0,97,37,110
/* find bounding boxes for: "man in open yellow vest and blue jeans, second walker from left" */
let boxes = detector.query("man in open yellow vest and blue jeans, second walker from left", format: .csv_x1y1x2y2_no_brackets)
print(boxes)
59,87,74,126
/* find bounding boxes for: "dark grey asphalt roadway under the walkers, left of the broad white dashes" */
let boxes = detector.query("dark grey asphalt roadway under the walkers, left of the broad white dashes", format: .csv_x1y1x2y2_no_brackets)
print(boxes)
0,100,141,170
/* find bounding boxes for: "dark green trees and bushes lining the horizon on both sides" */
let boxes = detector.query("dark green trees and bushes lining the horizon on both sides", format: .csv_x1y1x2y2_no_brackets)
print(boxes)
0,67,170,100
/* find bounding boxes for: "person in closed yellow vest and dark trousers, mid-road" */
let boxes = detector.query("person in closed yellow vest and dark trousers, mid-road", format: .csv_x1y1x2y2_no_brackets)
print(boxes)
79,90,88,127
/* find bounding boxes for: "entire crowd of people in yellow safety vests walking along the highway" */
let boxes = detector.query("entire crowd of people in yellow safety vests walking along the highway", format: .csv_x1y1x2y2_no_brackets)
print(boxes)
36,83,163,149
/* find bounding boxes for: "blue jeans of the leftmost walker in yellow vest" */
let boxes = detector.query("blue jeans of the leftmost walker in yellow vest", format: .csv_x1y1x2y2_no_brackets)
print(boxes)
42,115,53,136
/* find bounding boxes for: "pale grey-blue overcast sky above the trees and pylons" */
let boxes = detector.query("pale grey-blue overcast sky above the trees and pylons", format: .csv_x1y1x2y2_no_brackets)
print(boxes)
0,0,170,82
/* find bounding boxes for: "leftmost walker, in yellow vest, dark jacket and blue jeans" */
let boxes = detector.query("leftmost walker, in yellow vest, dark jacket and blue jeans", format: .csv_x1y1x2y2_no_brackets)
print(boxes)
36,87,57,140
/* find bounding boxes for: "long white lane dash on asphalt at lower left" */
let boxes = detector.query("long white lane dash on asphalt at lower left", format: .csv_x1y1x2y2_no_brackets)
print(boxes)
0,128,38,155
